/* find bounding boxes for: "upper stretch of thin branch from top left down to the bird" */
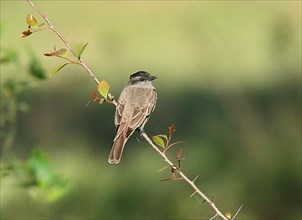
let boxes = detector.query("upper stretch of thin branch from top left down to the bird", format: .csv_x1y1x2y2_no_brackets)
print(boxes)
27,0,116,105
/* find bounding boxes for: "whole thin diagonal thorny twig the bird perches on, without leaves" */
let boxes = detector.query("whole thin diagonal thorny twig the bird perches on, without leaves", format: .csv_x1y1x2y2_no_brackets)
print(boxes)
27,0,231,220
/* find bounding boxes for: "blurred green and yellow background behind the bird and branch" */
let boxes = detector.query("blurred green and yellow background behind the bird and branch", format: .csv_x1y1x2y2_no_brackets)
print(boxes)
0,0,302,220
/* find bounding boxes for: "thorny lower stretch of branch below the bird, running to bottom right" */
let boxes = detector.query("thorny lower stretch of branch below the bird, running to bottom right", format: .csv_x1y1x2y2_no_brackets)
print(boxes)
141,132,229,220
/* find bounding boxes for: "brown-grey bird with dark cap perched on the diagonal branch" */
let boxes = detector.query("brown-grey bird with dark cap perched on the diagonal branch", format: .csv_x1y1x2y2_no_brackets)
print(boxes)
108,71,157,164
